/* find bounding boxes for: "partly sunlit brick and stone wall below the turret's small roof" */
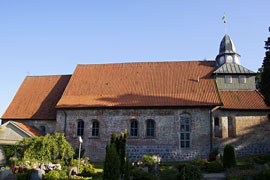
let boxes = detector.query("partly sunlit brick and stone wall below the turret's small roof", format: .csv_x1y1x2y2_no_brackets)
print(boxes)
213,110,270,156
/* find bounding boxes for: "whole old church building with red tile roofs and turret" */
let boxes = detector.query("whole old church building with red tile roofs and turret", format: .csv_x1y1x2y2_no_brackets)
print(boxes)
0,35,270,162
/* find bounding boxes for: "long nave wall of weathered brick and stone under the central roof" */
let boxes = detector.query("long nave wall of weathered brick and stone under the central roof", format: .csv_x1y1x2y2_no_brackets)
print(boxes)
57,108,210,162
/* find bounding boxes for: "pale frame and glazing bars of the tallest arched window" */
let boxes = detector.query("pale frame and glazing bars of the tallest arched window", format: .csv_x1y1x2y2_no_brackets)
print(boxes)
179,113,191,149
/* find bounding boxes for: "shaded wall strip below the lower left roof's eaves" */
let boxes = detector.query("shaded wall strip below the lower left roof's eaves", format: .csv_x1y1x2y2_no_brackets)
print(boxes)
2,119,56,134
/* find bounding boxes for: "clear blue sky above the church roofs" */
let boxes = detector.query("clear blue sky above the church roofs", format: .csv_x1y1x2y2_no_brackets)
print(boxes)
0,0,270,116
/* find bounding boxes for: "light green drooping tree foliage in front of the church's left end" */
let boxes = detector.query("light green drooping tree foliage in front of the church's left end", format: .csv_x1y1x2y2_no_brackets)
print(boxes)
17,133,74,161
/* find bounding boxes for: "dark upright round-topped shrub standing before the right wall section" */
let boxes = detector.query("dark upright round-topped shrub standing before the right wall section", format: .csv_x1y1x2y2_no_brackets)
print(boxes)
223,145,236,168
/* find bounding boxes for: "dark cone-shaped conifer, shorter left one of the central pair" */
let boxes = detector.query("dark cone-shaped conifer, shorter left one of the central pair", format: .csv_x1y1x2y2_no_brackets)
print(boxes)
103,143,120,180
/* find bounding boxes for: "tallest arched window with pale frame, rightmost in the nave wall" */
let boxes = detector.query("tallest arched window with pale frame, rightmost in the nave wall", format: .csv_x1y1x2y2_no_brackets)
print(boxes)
180,114,191,148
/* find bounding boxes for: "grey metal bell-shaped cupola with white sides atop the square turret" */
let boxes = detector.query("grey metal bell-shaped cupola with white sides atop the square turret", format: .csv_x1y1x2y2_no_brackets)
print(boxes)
216,34,240,67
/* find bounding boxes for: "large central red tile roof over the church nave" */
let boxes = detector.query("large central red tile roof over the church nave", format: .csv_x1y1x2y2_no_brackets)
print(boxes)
57,61,221,108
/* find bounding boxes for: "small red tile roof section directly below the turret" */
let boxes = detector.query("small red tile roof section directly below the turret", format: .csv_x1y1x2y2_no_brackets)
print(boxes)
220,90,270,110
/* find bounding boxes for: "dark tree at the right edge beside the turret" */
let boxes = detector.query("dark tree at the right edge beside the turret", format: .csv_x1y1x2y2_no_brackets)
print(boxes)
257,29,270,106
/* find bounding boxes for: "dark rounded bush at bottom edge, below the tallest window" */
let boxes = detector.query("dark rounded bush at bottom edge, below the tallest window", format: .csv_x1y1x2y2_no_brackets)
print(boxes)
177,165,203,180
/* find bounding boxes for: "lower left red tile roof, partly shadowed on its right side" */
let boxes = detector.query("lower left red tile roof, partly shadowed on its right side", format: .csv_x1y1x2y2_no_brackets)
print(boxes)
1,75,71,120
